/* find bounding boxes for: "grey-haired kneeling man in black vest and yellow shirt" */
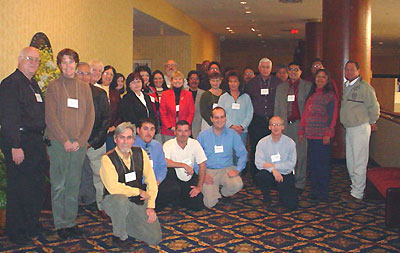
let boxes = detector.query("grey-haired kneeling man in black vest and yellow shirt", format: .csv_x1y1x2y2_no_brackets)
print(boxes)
100,122,162,250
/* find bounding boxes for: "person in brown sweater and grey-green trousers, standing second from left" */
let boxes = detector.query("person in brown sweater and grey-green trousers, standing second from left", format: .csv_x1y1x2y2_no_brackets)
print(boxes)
45,48,95,239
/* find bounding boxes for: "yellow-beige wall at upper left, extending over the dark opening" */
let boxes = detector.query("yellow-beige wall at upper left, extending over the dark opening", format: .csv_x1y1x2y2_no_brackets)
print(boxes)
0,0,219,78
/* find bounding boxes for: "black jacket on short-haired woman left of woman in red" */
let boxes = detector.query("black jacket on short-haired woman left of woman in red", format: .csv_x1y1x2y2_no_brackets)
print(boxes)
119,92,157,127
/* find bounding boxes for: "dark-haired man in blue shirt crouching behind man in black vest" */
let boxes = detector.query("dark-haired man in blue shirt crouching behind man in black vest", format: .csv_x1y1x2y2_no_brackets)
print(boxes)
133,118,180,212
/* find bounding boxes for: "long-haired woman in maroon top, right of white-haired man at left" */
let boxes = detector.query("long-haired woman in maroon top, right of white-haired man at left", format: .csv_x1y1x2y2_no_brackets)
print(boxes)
99,65,121,151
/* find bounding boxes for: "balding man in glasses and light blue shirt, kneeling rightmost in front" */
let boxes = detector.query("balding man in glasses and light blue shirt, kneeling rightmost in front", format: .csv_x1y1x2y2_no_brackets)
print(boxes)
255,116,298,210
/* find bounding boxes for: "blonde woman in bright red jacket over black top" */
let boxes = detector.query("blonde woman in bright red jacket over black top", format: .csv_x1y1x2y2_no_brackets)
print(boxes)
160,71,194,142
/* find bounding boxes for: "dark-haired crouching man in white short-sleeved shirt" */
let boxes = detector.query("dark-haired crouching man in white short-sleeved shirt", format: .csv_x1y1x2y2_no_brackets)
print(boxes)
163,120,207,211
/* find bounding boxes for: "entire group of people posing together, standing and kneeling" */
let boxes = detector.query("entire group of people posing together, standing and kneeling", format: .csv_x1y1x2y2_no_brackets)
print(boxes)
0,47,379,249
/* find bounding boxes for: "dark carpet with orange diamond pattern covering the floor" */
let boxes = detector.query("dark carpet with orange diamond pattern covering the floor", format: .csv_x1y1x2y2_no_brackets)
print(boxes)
0,161,400,252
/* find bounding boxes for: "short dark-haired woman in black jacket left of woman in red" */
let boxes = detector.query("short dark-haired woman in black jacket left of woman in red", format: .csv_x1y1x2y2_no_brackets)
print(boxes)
119,72,156,125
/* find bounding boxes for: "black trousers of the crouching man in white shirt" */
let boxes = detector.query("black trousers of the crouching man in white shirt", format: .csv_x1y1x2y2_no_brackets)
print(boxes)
156,168,204,211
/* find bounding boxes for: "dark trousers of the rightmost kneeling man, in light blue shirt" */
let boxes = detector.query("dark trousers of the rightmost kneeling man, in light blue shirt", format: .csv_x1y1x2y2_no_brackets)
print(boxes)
256,170,298,210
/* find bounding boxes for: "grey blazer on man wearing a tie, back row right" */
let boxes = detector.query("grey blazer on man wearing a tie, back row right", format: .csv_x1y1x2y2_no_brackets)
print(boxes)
274,79,312,126
